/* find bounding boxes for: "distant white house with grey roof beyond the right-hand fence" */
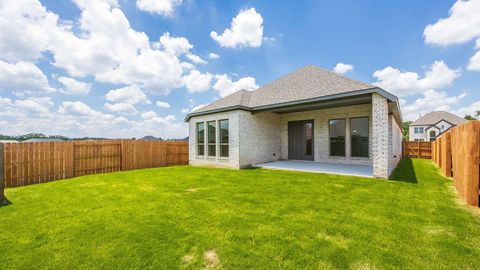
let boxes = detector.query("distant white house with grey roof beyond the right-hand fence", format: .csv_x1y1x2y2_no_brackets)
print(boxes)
408,111,466,142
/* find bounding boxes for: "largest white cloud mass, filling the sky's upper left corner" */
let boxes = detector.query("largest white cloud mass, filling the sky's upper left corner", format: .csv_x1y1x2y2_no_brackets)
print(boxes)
0,0,188,94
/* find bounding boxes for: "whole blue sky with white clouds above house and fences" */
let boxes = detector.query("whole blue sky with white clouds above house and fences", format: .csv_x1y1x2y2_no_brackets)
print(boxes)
0,0,480,138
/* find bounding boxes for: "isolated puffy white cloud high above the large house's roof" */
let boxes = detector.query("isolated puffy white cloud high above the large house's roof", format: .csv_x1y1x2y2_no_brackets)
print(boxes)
210,8,263,48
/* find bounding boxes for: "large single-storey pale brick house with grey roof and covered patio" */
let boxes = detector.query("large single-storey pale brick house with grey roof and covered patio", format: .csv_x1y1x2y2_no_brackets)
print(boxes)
185,66,402,178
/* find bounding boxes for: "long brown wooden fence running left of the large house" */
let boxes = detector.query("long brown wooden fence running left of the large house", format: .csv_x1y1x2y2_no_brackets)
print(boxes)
0,140,188,187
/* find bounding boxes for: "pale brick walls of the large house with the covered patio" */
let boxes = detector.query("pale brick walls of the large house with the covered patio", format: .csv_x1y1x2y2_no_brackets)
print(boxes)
189,94,402,178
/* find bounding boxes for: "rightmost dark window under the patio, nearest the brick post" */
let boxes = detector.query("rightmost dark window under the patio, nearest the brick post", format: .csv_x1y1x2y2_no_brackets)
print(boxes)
350,117,369,157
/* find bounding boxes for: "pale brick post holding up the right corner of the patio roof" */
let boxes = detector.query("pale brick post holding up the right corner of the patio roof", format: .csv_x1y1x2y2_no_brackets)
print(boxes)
372,93,389,178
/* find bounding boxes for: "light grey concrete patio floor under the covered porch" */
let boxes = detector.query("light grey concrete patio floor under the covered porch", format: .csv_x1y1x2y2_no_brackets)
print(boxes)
253,160,373,177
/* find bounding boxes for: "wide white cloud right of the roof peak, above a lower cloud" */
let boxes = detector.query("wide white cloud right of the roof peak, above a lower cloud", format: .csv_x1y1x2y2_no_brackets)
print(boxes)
373,61,460,97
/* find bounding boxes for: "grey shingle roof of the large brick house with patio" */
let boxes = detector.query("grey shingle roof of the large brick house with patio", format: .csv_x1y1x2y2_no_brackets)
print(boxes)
185,65,398,121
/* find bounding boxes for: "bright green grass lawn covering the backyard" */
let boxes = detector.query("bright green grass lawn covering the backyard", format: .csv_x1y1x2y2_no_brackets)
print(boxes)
0,159,480,269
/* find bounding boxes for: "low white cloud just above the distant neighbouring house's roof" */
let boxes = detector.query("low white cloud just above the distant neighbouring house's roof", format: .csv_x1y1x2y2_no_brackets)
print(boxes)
401,90,466,120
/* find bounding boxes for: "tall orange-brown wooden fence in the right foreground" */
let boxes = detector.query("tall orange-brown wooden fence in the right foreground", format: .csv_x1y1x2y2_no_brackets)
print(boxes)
432,121,480,206
